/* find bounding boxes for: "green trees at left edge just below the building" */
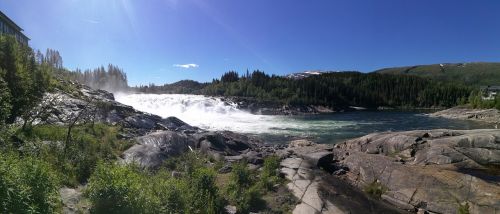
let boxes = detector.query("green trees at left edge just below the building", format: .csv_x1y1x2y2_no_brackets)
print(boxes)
0,35,62,124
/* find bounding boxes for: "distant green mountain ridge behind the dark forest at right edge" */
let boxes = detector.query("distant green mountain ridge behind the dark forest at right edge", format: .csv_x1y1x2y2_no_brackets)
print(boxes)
374,62,500,86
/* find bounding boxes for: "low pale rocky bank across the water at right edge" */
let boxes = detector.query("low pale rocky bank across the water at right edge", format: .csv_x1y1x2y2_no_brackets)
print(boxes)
430,106,500,124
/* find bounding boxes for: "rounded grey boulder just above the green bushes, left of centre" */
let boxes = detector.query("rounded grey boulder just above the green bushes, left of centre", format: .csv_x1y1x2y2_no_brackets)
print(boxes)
122,131,194,168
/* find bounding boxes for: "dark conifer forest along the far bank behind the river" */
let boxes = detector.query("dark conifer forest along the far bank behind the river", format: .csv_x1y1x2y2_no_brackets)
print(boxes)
200,70,472,108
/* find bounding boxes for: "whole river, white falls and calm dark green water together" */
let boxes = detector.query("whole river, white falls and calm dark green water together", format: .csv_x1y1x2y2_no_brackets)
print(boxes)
115,94,493,143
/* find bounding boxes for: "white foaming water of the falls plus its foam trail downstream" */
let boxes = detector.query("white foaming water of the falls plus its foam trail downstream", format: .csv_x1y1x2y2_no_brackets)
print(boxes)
115,94,354,136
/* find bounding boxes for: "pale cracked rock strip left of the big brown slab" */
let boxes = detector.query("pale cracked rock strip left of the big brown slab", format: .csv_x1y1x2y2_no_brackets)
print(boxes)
280,140,402,214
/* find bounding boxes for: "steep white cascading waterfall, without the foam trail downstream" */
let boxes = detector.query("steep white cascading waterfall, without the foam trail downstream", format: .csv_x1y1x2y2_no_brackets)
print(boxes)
115,94,279,134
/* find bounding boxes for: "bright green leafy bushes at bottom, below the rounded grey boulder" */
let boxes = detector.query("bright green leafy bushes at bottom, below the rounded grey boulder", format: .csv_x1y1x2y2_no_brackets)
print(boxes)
86,163,223,213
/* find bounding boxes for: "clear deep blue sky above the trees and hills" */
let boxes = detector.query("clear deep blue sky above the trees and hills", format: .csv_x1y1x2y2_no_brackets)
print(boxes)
0,0,500,85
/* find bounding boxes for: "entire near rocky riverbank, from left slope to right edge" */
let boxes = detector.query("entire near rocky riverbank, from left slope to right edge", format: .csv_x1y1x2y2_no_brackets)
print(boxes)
36,83,500,213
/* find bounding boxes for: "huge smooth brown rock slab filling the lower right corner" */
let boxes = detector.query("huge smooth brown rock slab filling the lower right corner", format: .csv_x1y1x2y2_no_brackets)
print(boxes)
333,129,500,213
